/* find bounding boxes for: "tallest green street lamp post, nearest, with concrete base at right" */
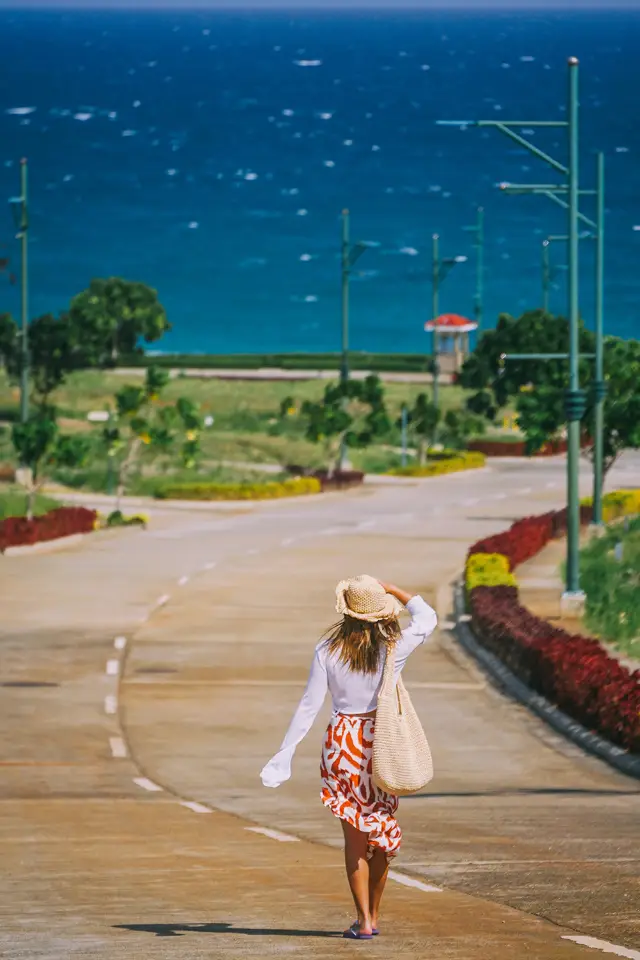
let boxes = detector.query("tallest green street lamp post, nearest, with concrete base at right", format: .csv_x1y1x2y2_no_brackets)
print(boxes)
438,57,593,609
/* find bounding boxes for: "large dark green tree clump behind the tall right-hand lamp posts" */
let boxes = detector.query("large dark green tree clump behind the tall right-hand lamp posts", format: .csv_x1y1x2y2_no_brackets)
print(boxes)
460,310,640,473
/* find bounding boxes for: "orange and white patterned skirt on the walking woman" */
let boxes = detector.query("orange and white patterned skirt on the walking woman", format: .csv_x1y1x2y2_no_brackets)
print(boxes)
320,713,402,858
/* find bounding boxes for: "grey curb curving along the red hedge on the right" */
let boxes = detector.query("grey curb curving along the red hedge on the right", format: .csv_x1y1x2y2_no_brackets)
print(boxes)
454,581,640,780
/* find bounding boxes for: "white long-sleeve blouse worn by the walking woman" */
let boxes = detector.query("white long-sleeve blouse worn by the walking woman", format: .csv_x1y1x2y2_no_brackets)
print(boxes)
260,596,438,787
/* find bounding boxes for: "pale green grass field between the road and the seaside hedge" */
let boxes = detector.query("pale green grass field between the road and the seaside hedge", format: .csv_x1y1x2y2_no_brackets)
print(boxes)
0,370,476,493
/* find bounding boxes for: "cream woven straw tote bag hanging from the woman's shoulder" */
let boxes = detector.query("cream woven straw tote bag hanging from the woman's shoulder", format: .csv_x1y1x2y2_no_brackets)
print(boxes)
373,647,433,797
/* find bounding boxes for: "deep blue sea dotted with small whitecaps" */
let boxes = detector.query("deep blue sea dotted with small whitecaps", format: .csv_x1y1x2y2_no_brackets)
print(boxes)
0,10,640,352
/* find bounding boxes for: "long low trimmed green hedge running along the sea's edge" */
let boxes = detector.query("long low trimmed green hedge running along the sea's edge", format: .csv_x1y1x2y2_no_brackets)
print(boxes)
118,351,431,373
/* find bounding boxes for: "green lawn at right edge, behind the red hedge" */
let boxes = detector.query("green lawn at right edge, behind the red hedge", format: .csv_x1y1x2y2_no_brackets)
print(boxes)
580,517,640,659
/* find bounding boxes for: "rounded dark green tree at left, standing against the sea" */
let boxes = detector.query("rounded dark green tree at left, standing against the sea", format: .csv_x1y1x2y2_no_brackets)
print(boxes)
69,277,171,367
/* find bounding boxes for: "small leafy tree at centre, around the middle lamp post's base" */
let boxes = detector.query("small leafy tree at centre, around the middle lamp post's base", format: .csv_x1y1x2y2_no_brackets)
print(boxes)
302,375,391,473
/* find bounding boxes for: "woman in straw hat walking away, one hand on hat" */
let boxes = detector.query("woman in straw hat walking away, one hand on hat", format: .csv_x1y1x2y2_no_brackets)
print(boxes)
261,575,437,940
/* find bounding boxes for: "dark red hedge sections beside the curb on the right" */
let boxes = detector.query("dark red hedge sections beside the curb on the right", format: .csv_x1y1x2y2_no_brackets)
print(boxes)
469,509,640,753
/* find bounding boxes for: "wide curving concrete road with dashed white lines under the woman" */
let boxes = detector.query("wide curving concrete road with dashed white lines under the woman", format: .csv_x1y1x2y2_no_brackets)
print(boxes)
0,459,640,960
